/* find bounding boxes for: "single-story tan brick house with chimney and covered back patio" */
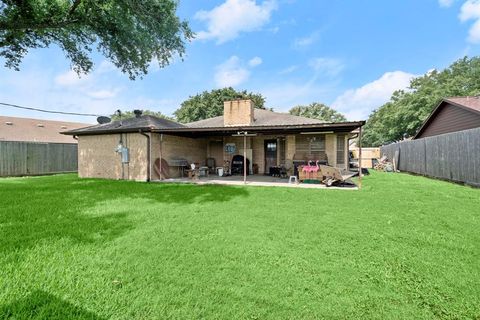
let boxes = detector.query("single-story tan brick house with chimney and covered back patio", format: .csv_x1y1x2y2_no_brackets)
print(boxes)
63,100,365,181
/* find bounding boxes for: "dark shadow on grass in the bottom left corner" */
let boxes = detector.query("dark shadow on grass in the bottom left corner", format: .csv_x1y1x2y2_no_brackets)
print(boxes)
0,290,103,320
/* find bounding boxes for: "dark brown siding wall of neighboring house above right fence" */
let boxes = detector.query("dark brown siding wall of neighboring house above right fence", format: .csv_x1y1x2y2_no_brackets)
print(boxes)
416,103,480,139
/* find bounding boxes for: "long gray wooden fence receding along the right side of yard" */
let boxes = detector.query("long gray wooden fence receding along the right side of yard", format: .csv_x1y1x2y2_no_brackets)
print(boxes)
380,128,480,187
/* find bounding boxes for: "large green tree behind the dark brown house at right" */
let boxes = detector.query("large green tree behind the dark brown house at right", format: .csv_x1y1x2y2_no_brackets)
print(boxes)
362,57,480,146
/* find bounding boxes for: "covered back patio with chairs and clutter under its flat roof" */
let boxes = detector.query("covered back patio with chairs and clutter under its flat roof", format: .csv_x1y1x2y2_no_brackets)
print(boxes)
151,122,363,189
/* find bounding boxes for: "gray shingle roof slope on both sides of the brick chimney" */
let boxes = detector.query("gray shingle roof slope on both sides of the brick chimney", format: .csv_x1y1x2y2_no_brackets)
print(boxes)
186,109,325,128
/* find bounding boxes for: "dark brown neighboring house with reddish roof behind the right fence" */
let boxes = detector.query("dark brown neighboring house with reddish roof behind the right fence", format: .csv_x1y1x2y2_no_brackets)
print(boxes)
413,96,480,139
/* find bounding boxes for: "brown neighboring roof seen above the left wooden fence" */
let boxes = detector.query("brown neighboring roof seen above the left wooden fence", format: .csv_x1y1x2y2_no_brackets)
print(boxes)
0,116,89,143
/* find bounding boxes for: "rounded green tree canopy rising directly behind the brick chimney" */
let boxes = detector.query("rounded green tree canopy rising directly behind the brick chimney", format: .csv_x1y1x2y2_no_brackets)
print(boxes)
174,87,265,123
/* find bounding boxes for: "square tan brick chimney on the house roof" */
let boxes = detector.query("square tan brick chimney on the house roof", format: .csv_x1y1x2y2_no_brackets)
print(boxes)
223,100,254,127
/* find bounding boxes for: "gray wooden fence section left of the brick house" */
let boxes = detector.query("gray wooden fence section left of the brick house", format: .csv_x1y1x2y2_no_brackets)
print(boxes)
0,141,78,177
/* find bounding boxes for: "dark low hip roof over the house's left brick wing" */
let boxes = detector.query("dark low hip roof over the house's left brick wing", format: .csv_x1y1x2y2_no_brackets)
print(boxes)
62,115,185,135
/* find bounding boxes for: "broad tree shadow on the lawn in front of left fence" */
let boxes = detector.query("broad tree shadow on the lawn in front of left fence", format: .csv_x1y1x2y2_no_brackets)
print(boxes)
0,175,248,252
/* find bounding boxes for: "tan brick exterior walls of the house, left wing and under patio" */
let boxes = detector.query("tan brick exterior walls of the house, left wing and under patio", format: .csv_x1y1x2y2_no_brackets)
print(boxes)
78,133,348,181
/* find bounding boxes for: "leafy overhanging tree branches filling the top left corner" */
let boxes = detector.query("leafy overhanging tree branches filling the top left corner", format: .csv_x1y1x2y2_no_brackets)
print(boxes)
0,0,193,79
